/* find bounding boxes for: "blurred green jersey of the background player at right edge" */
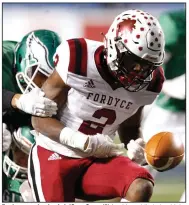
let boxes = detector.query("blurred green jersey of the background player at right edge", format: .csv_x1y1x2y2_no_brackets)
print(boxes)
156,10,186,112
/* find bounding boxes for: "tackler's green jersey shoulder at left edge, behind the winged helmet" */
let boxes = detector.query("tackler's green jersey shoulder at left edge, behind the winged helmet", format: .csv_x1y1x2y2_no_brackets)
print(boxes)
2,41,21,93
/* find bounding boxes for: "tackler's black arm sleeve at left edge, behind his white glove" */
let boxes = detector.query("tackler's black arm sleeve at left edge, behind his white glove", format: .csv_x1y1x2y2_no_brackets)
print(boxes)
2,89,16,112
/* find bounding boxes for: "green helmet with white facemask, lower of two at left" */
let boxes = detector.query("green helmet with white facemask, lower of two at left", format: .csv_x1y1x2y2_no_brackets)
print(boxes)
3,126,35,181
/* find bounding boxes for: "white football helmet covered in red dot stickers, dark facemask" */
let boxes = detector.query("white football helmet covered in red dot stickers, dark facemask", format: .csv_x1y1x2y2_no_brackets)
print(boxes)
104,10,165,92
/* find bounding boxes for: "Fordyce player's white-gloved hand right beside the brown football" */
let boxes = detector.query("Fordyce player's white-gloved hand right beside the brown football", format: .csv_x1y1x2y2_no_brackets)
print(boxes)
127,138,146,165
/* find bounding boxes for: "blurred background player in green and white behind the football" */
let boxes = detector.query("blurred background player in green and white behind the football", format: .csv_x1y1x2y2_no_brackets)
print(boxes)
143,10,186,202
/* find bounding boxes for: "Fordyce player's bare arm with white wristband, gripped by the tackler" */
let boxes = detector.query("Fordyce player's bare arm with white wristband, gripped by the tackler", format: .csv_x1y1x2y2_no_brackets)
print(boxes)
32,70,89,151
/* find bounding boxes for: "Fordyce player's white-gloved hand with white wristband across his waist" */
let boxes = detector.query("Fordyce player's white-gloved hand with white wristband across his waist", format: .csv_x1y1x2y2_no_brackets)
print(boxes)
59,127,124,158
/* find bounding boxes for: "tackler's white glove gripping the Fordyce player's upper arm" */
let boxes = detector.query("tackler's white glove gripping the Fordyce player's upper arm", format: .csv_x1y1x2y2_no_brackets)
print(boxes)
15,88,58,117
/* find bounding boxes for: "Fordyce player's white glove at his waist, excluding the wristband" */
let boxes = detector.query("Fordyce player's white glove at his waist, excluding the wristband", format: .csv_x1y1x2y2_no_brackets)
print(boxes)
85,134,124,158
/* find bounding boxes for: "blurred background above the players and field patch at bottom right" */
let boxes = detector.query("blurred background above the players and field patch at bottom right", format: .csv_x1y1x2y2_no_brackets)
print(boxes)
2,3,185,202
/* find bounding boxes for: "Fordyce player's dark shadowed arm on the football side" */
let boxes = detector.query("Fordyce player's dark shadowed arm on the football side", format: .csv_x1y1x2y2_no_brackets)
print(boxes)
118,107,143,147
